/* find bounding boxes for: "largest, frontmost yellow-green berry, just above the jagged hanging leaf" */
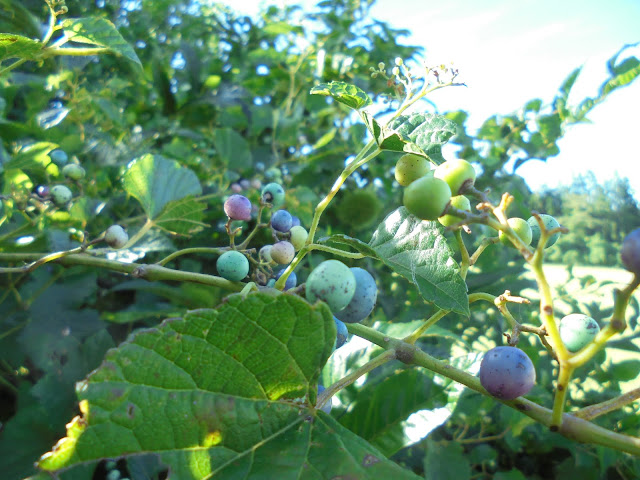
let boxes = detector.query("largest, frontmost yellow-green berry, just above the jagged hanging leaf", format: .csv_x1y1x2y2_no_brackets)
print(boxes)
403,176,451,220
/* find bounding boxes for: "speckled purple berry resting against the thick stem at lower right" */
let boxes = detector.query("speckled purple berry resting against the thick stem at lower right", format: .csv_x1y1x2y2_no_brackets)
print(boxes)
480,347,536,400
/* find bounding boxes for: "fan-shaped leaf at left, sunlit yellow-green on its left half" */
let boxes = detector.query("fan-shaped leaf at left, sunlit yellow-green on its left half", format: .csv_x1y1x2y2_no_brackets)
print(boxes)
123,154,202,220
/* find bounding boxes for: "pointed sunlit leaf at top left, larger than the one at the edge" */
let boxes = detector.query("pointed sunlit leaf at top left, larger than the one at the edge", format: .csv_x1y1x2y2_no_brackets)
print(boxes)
62,17,142,67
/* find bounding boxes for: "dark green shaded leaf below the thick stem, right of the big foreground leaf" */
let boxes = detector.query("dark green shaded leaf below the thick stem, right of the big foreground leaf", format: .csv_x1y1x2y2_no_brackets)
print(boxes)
340,369,447,456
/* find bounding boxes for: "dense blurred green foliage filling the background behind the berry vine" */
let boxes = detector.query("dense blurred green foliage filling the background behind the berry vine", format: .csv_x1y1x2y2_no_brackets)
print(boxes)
0,0,640,480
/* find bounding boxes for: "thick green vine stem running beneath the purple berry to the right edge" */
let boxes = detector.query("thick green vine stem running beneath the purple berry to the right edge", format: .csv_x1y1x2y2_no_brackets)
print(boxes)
347,323,640,456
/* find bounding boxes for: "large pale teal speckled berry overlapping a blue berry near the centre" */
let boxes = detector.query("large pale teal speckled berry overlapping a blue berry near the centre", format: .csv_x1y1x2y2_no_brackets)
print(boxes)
306,260,356,312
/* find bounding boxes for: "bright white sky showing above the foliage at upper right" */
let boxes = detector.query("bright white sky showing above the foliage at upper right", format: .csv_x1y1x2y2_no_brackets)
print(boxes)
230,0,640,200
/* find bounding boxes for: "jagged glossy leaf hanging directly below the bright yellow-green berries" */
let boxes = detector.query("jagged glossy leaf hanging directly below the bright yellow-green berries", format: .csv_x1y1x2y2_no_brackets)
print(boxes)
369,207,469,316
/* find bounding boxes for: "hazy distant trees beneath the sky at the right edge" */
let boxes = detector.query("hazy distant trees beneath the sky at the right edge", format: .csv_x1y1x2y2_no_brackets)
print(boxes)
532,172,640,266
